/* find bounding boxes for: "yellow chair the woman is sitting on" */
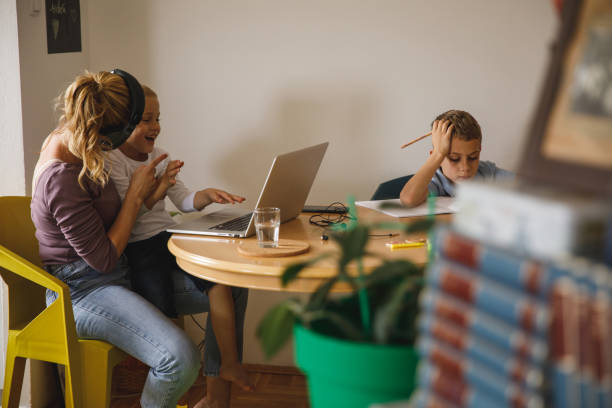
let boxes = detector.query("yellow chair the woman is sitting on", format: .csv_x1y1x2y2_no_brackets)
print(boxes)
0,197,127,408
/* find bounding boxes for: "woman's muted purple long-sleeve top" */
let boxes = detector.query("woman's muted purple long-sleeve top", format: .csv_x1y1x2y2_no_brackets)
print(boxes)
31,161,121,273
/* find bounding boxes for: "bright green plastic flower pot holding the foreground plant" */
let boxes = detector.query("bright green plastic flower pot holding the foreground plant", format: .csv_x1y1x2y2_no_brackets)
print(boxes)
293,325,418,408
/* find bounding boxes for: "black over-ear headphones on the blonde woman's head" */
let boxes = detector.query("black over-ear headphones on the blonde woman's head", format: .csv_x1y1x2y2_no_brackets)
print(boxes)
100,68,145,150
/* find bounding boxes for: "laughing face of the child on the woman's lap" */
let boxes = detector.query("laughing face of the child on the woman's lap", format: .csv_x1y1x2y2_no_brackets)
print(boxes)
119,96,161,160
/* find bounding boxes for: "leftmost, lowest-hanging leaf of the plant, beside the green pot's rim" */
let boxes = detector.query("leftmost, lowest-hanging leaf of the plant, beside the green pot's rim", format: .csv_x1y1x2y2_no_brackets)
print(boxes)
255,298,302,359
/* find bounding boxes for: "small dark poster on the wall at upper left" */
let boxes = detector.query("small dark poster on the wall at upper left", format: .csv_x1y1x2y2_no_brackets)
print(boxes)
45,0,81,54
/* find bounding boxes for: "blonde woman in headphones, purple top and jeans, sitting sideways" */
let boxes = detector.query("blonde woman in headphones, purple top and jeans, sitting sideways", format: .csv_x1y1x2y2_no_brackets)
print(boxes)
31,70,200,407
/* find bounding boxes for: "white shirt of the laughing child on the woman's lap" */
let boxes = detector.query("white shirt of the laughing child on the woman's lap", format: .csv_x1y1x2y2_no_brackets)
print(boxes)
105,147,195,242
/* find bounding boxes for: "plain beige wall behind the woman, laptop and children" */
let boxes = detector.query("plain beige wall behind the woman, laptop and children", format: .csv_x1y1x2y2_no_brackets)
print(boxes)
13,0,557,370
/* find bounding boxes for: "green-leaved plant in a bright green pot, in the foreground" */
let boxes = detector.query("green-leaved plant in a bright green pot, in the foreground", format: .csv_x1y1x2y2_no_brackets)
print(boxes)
257,199,433,408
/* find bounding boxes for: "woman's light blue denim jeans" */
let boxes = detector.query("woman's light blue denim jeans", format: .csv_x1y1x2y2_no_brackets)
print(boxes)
46,256,248,408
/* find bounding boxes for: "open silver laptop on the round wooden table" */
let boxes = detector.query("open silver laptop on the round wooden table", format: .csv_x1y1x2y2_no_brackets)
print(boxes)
168,142,329,238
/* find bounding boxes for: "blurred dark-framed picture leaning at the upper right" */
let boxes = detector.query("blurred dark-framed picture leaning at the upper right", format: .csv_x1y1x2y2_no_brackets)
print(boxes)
520,0,612,195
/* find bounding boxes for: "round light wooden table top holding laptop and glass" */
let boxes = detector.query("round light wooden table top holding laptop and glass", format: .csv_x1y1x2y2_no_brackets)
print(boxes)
168,207,436,292
